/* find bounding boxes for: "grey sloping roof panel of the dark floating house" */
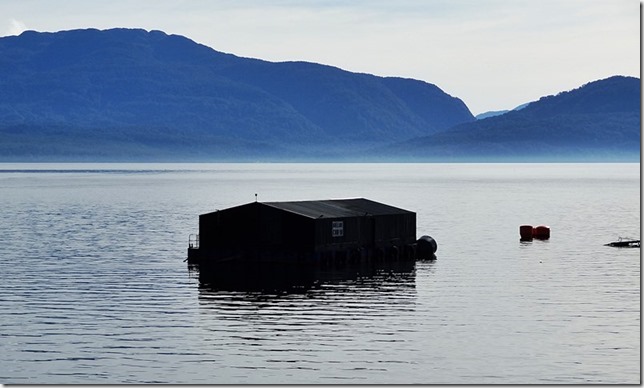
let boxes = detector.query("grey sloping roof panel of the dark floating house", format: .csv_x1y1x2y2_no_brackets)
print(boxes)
262,198,413,218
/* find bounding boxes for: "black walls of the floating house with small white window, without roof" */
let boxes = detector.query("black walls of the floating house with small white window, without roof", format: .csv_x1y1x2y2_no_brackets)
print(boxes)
199,202,416,254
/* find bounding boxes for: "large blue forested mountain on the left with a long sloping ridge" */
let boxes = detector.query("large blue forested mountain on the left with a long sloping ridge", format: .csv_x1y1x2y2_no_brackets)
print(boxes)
0,29,474,161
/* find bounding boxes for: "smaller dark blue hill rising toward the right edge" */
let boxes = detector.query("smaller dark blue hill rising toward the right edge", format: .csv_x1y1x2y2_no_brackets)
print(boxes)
372,76,641,161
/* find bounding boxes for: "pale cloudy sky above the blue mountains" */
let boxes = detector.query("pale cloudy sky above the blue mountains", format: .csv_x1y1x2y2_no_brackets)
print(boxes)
0,0,641,115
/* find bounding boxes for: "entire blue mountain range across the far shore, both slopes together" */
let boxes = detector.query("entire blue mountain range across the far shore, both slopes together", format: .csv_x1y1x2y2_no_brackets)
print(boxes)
0,29,640,161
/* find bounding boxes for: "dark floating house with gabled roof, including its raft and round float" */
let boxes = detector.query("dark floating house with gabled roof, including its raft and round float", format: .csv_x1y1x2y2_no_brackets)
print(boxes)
188,198,437,270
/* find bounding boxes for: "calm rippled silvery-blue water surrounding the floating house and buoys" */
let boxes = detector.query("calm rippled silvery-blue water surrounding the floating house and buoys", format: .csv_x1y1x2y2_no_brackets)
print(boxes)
0,164,641,384
